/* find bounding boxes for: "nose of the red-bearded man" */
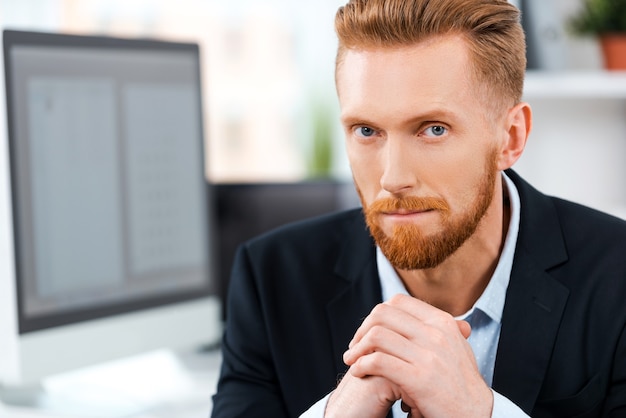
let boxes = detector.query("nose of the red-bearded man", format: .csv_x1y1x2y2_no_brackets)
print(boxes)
380,137,417,195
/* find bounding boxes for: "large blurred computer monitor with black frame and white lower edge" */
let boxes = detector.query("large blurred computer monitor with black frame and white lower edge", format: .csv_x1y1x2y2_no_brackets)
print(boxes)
0,30,221,398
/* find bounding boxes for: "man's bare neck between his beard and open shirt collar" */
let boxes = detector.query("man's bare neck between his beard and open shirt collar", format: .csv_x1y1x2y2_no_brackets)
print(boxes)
398,179,510,316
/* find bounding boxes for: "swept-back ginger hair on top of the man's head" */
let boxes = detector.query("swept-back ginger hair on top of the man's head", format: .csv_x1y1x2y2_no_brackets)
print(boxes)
335,0,526,111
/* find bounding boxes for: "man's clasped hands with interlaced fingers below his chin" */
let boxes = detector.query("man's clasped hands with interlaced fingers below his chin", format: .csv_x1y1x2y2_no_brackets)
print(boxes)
325,295,493,418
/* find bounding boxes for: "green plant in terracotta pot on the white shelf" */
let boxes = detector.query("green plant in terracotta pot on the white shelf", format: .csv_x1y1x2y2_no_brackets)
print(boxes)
569,0,626,70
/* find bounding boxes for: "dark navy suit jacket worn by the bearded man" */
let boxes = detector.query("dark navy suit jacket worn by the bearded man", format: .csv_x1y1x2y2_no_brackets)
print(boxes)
213,171,626,418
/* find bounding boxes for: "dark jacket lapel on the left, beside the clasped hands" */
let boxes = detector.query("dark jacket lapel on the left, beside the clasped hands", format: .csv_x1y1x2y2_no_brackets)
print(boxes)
326,212,382,373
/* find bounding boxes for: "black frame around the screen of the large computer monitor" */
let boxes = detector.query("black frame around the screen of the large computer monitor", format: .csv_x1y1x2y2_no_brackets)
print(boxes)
3,29,217,334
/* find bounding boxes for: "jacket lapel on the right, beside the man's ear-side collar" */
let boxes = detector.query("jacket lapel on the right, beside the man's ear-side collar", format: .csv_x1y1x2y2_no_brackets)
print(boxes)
493,172,569,413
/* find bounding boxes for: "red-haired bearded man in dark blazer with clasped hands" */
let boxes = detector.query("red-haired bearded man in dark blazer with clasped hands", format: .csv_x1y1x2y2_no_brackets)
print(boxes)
213,0,626,418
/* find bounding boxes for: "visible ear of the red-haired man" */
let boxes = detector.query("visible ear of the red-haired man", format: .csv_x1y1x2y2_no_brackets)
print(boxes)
498,103,532,170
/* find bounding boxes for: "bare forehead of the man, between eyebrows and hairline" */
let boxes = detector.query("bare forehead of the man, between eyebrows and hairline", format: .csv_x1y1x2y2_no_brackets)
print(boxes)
336,36,473,120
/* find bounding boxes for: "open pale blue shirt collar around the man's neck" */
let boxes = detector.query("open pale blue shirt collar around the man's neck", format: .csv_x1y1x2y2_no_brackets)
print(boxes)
376,172,521,323
